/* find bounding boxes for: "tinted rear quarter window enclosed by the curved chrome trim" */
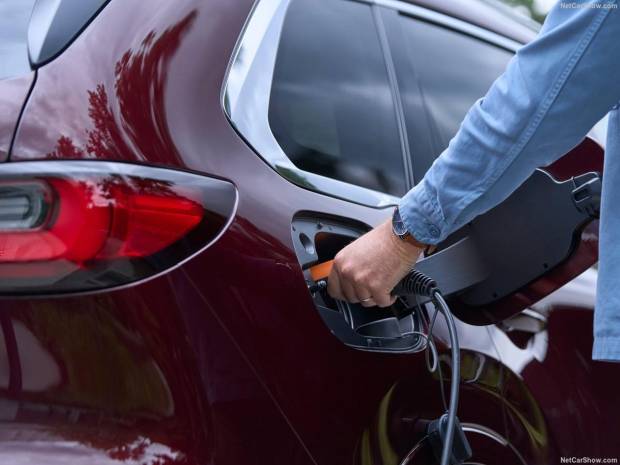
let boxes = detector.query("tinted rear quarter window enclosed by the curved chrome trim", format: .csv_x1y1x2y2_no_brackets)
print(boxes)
269,0,406,195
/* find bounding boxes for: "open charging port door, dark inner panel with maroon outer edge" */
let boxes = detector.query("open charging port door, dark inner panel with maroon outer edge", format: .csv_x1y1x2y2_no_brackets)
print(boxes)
446,170,602,324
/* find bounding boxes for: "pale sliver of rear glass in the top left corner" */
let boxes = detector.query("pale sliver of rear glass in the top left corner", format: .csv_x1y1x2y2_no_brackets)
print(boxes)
0,0,35,79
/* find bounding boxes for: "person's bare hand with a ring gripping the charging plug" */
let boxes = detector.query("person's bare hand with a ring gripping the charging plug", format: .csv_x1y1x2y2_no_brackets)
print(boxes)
327,220,422,307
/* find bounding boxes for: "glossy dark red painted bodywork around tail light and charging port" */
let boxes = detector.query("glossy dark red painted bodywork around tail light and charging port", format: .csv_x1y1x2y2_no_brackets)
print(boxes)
0,0,620,465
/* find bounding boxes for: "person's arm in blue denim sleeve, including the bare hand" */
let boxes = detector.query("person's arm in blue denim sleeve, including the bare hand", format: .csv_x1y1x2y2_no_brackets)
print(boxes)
328,0,620,306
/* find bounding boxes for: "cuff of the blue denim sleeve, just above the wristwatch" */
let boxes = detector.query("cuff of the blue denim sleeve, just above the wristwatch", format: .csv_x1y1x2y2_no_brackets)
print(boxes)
398,180,448,245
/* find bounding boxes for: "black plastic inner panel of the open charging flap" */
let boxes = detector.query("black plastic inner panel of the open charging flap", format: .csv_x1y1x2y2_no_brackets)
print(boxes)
456,170,600,311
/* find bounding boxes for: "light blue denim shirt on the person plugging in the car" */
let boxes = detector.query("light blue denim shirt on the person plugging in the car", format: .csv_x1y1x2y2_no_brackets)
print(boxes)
399,0,620,361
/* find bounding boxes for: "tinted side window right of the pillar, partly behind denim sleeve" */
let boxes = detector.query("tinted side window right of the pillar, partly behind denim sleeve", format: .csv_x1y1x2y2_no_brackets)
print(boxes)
385,10,513,180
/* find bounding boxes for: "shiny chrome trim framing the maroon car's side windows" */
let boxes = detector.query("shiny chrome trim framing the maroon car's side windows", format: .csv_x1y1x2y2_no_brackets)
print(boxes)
221,0,521,208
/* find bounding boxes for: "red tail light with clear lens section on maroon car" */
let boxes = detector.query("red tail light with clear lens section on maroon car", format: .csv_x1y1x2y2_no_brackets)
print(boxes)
0,161,236,295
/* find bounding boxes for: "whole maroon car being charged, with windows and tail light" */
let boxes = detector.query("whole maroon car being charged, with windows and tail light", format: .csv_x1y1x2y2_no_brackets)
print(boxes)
0,0,620,465
